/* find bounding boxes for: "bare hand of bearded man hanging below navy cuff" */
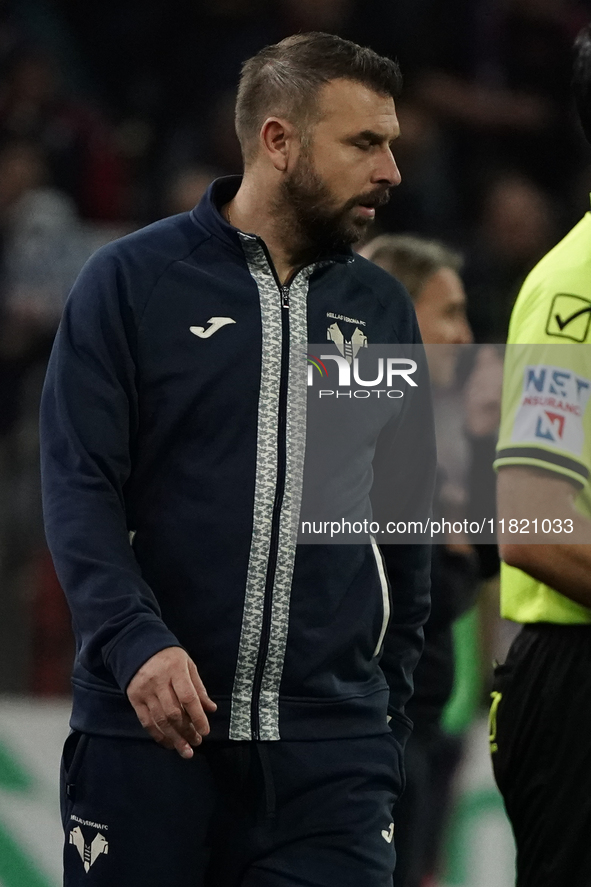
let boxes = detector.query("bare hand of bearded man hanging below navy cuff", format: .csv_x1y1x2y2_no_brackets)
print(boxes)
127,647,217,758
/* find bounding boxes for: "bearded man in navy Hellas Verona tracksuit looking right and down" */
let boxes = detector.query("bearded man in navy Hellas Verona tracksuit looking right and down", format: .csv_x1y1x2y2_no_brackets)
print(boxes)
42,34,434,887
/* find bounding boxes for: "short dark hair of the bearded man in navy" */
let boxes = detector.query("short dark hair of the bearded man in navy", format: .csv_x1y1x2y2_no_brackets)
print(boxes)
236,31,402,162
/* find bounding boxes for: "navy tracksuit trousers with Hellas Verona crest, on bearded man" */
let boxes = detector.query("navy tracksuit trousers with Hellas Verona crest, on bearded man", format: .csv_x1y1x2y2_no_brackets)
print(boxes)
62,733,402,887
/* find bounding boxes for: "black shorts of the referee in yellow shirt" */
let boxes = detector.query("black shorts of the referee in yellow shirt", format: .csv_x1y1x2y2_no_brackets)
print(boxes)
490,623,591,887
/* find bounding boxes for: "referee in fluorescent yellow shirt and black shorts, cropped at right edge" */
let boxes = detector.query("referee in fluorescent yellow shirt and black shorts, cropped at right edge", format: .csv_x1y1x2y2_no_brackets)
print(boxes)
491,26,591,887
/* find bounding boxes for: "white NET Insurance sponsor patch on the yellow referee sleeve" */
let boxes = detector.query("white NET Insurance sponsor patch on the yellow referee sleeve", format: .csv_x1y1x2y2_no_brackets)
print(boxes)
511,364,591,457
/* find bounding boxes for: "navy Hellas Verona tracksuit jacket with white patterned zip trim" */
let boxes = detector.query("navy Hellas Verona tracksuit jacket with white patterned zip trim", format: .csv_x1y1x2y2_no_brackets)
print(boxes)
41,177,435,744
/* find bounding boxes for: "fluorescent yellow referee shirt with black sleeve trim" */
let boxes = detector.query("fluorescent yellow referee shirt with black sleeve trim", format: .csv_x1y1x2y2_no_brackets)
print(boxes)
495,213,591,624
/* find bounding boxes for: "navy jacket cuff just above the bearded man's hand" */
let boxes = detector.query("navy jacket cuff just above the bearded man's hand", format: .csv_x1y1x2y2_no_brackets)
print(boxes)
104,616,182,692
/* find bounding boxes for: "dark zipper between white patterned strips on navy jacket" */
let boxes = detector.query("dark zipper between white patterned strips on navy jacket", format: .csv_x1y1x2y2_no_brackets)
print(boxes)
251,238,294,740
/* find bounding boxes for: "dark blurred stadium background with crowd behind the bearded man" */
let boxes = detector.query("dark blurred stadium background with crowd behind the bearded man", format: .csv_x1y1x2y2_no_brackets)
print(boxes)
0,0,591,887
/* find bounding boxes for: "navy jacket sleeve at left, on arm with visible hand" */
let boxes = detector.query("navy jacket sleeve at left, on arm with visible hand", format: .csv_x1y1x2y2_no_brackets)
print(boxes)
41,247,180,690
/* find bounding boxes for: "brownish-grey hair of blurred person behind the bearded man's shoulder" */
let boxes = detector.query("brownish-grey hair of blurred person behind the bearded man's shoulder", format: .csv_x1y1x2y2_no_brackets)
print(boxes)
363,234,464,302
